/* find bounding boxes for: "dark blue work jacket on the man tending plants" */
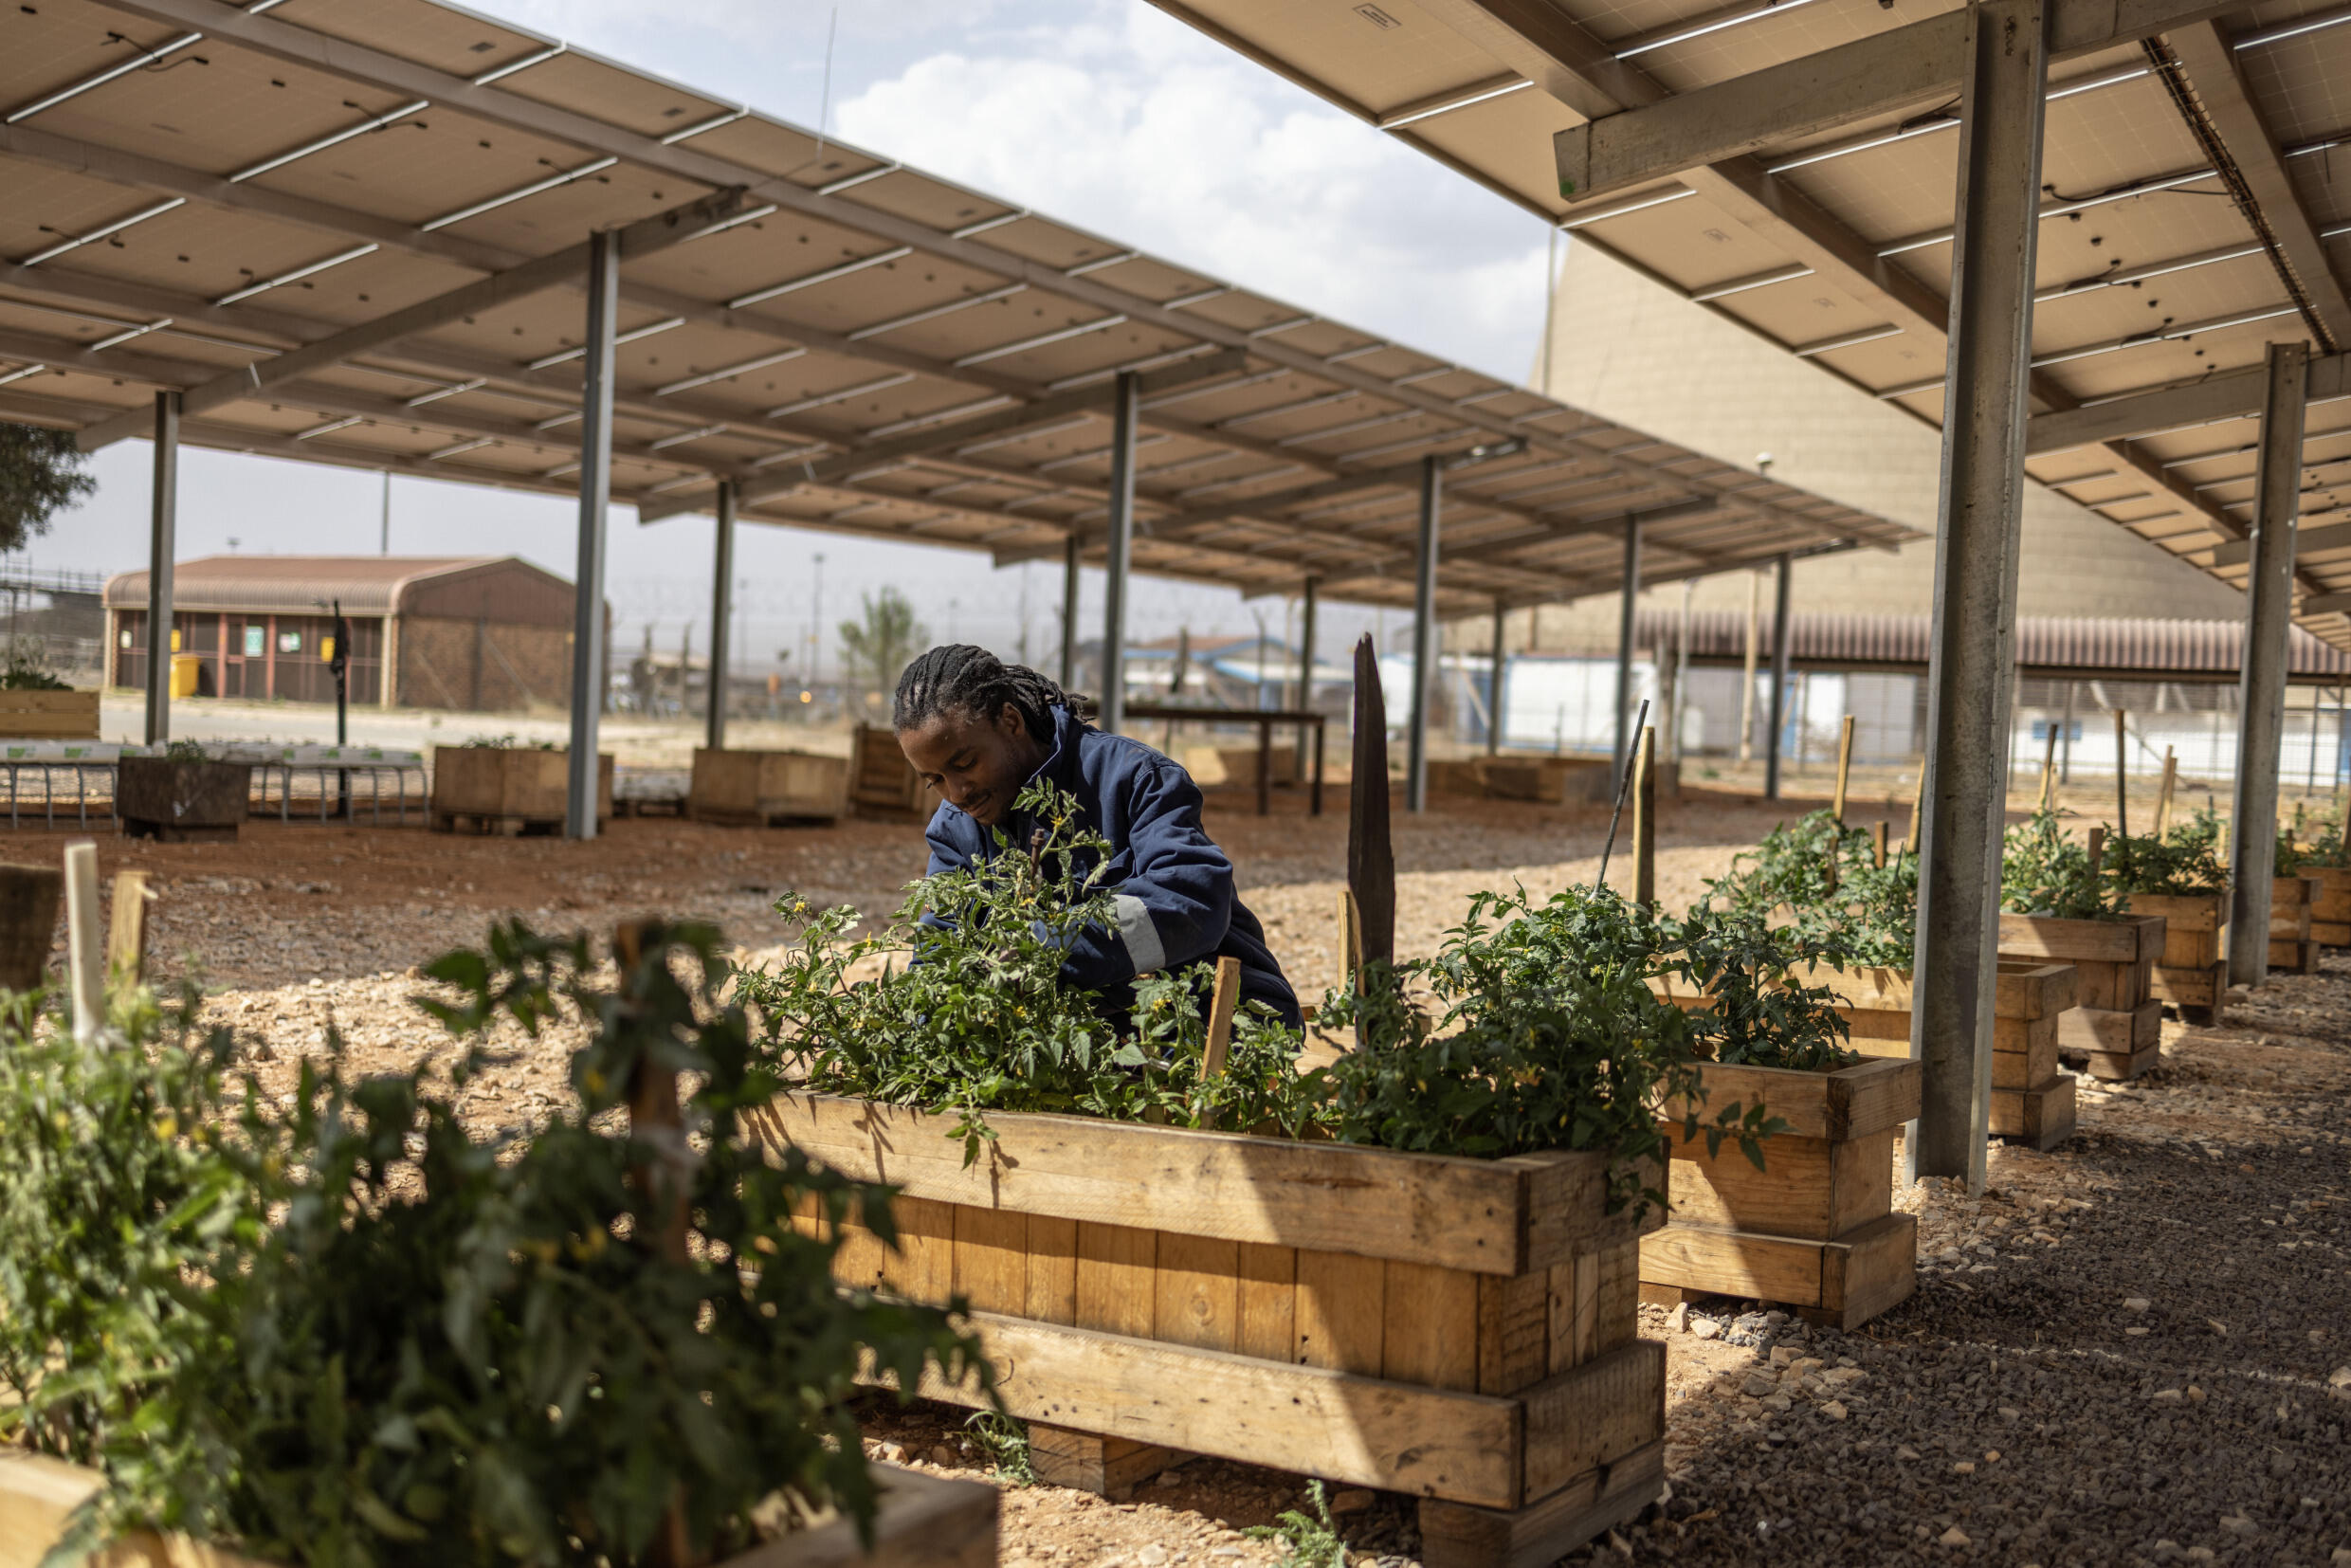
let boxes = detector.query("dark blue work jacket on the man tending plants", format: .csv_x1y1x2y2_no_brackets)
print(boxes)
924,707,1300,1030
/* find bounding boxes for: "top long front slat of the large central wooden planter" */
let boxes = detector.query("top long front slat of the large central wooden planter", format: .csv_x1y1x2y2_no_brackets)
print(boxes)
762,1096,1579,1274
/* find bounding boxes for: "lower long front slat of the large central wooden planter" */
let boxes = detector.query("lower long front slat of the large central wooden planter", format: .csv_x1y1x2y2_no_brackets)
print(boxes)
921,1312,1526,1509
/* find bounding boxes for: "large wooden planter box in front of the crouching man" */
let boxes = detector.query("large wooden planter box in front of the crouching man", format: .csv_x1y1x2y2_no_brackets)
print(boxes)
757,1096,1665,1568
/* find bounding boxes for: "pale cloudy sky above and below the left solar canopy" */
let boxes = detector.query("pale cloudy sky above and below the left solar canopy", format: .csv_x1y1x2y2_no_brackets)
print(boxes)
30,0,1544,665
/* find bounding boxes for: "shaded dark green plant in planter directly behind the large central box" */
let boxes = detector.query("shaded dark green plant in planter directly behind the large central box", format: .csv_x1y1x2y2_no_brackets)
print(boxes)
1667,907,1860,1072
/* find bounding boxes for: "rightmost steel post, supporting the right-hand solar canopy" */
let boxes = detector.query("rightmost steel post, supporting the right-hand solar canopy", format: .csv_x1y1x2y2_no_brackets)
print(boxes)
2229,343,2308,985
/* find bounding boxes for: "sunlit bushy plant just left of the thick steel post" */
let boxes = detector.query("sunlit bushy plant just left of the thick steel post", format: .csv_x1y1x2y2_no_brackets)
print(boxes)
1706,811,1919,969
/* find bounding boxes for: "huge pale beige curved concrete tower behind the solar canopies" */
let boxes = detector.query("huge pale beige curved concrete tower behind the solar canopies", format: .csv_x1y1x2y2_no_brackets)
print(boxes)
1504,240,2245,648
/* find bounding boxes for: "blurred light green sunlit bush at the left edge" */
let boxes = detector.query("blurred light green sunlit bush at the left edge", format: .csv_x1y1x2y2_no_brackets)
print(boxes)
0,992,270,1465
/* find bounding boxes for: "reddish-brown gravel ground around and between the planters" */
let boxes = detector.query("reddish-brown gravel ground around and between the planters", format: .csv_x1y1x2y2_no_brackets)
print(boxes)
0,793,2351,1568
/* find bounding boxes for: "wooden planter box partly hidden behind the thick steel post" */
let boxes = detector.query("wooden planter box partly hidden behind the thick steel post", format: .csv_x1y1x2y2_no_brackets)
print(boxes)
1765,959,2076,1161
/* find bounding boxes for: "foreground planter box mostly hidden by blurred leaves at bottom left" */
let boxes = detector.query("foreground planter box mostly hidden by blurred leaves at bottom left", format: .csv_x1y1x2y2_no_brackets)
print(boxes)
0,1449,999,1568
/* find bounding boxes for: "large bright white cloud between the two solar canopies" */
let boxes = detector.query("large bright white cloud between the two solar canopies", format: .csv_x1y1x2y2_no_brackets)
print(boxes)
834,0,1544,378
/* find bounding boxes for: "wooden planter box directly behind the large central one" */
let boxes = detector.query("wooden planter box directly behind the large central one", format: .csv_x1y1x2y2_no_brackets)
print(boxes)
1641,1058,1919,1328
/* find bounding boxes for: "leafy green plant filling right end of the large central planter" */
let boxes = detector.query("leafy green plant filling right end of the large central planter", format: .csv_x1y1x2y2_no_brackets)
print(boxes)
1323,888,1777,1215
